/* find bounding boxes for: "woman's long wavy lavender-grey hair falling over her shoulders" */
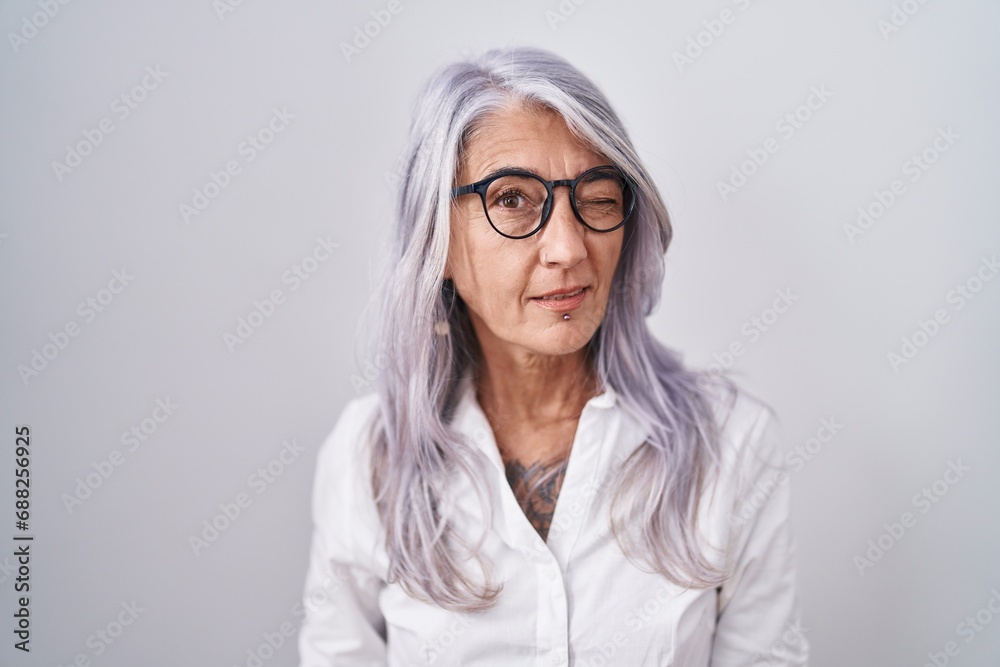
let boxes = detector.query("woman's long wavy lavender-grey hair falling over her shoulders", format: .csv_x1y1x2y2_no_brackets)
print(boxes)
371,48,733,611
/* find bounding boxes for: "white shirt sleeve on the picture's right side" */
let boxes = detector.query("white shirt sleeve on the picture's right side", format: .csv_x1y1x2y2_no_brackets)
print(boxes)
711,406,809,667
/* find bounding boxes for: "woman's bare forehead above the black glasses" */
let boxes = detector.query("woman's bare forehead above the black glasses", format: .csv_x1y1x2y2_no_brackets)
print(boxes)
459,105,607,183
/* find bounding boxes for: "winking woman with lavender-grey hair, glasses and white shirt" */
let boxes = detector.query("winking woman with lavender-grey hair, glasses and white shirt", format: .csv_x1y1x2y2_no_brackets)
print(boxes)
299,49,808,667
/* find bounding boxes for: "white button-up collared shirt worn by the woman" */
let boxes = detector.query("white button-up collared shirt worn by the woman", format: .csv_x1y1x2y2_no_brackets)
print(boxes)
298,375,809,667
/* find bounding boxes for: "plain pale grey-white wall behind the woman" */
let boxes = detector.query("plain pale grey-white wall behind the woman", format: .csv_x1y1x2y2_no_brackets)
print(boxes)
0,0,1000,667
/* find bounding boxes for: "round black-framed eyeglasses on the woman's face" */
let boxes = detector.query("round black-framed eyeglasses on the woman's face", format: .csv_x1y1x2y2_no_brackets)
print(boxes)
452,165,635,239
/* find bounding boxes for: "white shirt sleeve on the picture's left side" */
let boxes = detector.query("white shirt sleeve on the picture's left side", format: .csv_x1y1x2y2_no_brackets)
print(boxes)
298,399,386,667
